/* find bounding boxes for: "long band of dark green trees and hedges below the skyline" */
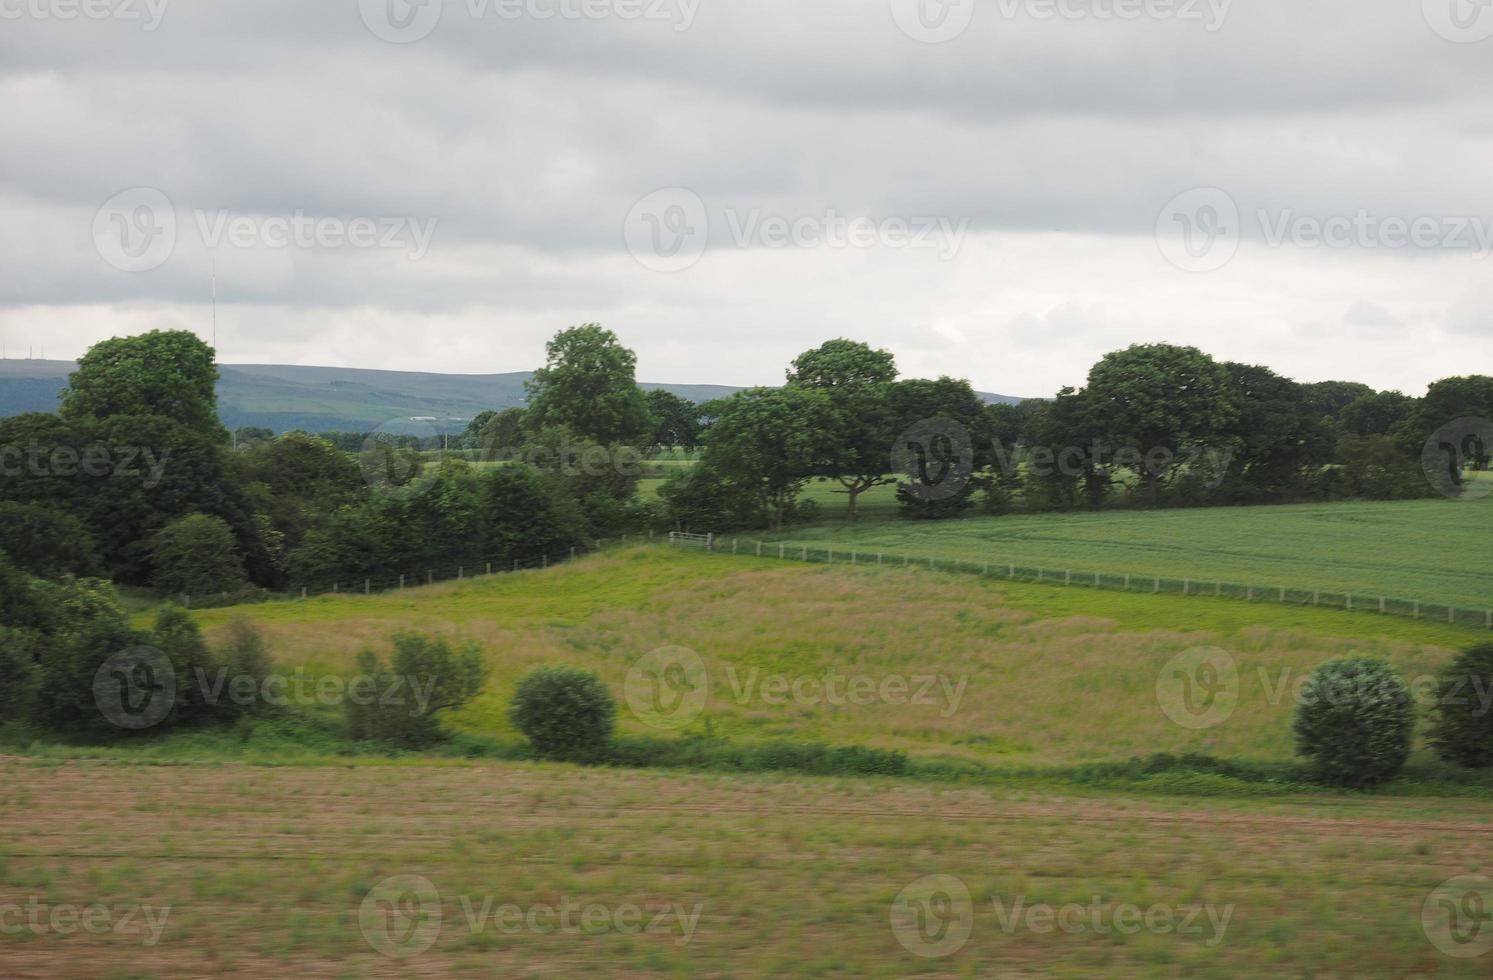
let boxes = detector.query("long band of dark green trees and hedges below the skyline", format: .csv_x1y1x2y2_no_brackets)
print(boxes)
0,324,1493,596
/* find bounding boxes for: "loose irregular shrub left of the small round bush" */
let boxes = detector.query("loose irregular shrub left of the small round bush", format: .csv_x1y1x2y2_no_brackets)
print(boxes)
343,632,487,745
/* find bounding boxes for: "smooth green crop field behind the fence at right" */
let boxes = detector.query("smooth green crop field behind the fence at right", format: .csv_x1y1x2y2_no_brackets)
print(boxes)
764,486,1493,610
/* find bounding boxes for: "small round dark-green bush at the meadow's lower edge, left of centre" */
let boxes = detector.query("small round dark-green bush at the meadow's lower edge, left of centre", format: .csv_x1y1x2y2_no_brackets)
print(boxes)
508,666,617,757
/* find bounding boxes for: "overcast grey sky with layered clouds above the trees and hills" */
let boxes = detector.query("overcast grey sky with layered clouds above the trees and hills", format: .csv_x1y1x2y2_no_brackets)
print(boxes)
0,0,1493,396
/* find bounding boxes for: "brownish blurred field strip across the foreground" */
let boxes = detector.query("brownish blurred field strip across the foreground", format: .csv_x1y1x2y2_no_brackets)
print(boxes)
0,759,1493,980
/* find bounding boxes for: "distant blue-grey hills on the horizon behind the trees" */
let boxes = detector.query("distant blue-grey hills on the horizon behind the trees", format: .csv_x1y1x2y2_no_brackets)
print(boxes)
0,360,1021,432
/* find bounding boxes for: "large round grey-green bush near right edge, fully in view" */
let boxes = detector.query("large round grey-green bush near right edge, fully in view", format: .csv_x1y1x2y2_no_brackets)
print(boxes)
1291,657,1415,787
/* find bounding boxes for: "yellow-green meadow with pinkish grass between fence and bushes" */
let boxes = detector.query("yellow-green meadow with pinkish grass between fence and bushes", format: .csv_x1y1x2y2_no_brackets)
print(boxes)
163,547,1483,765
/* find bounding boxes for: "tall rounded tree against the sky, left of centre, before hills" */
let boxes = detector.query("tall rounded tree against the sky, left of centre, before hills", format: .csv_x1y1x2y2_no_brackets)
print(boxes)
524,323,649,445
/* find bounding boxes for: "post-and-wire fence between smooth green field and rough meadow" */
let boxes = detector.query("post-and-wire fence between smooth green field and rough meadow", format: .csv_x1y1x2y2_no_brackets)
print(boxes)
669,535,1493,630
